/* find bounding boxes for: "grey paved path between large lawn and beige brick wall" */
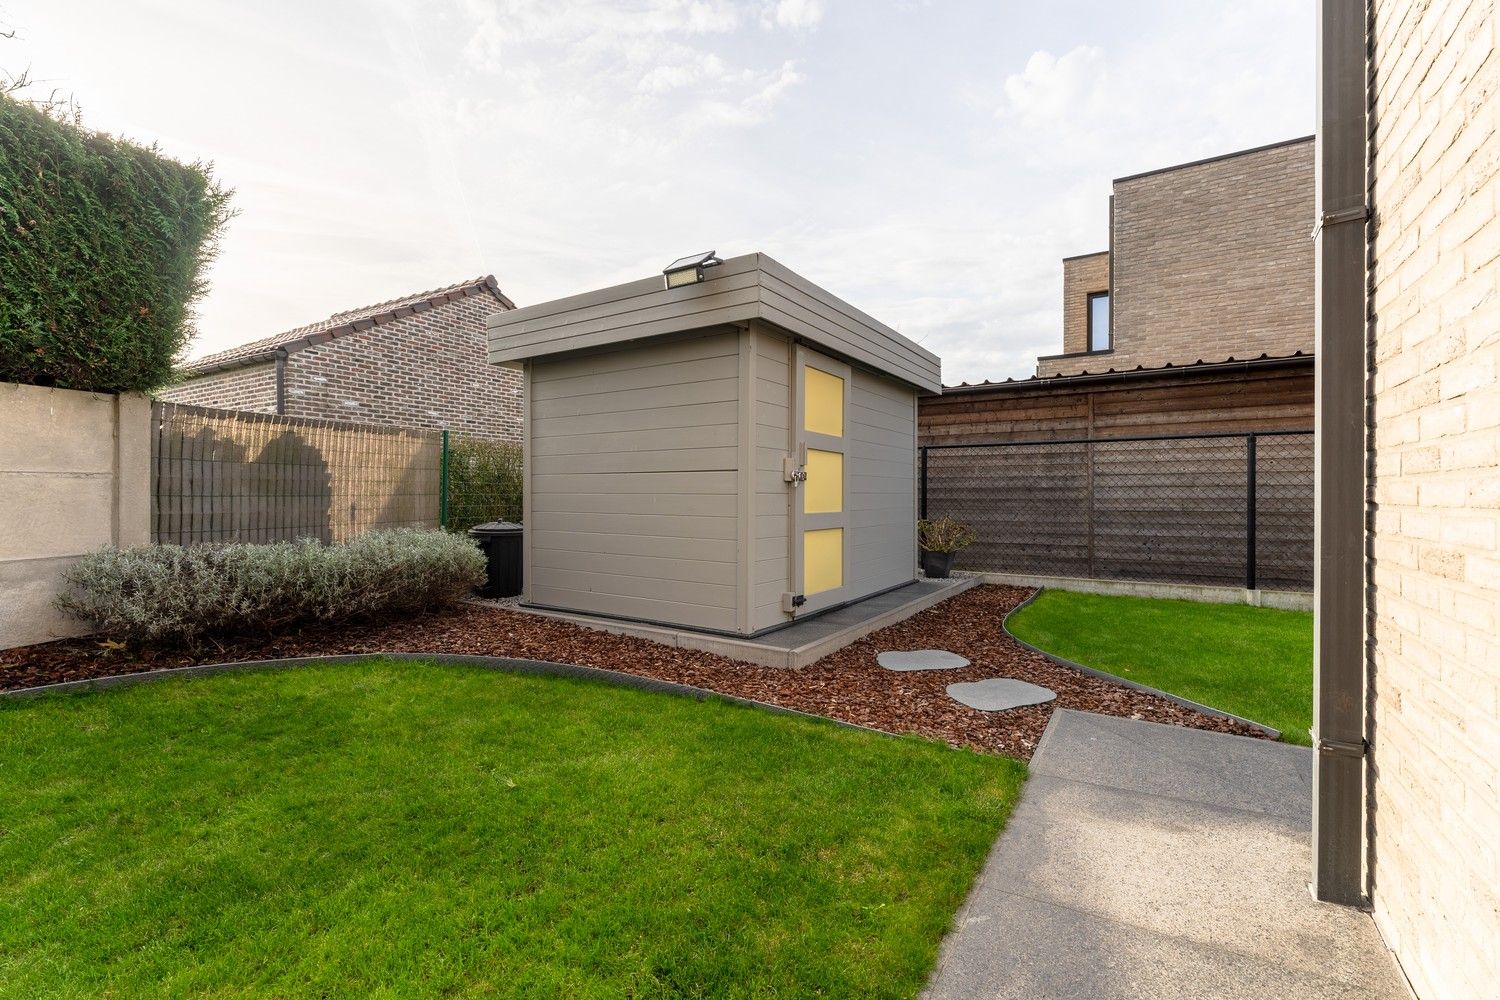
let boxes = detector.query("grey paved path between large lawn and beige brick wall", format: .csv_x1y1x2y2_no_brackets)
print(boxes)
924,709,1409,1000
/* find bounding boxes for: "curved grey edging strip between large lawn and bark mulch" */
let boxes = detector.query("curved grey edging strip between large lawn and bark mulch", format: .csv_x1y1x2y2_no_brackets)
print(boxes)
0,652,899,739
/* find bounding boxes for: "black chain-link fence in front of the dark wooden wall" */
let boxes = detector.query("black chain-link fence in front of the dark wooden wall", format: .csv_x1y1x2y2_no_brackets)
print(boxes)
920,430,1313,591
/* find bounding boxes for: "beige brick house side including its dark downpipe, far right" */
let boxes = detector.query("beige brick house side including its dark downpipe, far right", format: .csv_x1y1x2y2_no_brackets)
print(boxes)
1314,0,1500,999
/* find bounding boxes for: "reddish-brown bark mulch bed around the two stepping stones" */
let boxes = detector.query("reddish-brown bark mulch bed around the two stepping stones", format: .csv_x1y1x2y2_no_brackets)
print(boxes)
0,586,1265,760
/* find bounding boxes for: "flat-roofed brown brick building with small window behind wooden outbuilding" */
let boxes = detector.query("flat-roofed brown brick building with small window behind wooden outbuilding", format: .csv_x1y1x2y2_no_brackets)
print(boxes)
1037,136,1314,376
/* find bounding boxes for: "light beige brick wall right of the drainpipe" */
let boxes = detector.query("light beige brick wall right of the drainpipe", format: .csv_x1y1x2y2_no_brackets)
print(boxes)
1370,0,1500,997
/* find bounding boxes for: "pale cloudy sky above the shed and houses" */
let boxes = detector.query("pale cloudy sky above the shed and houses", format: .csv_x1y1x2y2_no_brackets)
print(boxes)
0,0,1314,382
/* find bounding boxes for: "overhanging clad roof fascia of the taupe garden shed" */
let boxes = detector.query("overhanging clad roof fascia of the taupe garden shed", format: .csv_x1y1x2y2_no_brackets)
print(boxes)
488,253,942,393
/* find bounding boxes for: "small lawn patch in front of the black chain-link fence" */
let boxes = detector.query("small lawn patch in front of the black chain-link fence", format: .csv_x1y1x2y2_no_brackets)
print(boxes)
1010,591,1313,745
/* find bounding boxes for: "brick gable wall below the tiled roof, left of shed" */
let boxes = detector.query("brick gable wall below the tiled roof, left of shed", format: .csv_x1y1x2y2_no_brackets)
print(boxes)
159,292,521,441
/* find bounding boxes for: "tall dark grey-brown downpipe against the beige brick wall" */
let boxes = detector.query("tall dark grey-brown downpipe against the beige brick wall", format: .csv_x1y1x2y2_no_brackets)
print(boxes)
1310,0,1370,906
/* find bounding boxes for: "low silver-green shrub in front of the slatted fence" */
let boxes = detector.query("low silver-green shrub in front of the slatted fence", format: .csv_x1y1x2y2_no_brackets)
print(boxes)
57,529,485,646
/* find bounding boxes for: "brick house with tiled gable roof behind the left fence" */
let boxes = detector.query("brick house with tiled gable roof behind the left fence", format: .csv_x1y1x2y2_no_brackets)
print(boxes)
158,276,521,441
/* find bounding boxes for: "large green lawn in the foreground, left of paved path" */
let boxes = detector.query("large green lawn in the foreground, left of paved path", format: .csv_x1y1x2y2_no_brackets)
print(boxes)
0,661,1025,999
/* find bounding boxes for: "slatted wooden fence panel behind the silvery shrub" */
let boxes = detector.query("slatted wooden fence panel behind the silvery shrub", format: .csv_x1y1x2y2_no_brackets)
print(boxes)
152,402,444,546
